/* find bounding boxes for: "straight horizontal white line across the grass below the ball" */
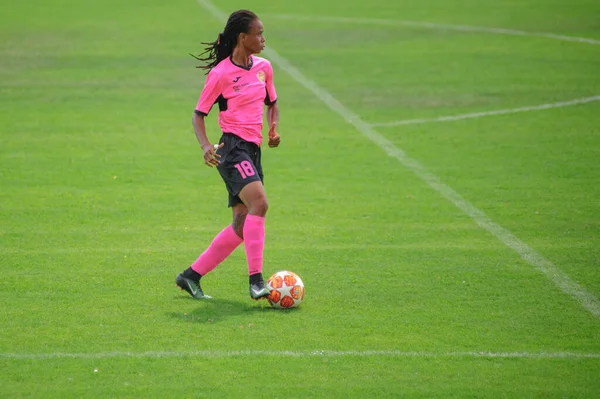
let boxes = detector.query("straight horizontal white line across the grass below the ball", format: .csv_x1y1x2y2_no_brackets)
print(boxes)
0,350,600,360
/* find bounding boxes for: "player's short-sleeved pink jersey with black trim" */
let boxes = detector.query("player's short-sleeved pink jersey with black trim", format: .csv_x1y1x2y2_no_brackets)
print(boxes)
196,56,277,145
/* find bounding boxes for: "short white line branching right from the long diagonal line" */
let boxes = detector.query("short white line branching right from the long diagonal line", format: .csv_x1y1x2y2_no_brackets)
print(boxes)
371,96,600,127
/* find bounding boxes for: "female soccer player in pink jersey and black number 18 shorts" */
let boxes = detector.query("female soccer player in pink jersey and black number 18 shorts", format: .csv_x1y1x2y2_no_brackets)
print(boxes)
175,10,280,299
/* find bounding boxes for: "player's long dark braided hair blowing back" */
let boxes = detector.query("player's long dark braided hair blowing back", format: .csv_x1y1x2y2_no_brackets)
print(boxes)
190,10,258,73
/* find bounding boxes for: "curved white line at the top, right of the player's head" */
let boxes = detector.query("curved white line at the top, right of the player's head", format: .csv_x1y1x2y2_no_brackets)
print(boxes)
268,14,600,45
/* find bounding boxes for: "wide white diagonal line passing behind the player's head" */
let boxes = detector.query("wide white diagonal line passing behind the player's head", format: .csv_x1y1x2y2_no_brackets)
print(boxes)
197,0,600,318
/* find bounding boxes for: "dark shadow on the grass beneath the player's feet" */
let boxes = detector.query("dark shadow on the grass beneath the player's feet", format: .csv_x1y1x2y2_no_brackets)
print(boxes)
167,297,275,324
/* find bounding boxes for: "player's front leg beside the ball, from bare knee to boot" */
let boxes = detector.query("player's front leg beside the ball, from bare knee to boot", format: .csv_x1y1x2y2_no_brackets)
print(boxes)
239,181,270,299
